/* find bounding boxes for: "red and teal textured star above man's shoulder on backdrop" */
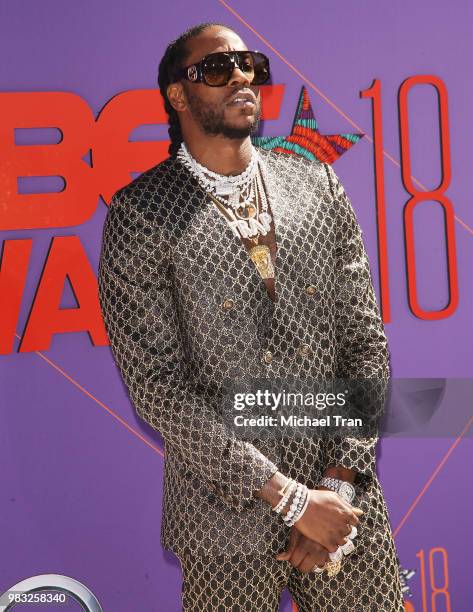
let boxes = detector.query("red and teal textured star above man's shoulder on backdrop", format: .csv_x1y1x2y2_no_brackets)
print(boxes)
251,87,364,164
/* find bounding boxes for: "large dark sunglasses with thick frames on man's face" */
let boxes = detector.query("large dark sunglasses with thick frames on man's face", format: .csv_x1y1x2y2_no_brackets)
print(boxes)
174,51,270,87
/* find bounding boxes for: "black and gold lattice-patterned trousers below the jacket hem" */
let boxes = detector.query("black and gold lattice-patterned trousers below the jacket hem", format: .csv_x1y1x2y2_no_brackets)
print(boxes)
175,533,404,612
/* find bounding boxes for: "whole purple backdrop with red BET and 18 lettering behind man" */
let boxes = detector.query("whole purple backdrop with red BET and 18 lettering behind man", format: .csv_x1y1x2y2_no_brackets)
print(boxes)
0,0,473,612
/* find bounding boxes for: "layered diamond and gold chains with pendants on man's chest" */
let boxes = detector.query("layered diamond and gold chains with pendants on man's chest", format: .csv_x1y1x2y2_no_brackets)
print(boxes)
177,142,274,278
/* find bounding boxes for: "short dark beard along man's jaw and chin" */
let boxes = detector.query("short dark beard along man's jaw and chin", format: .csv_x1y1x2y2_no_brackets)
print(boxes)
183,89,261,139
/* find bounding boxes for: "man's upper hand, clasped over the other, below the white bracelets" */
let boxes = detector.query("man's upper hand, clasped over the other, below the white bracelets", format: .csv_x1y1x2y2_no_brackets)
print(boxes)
294,489,363,552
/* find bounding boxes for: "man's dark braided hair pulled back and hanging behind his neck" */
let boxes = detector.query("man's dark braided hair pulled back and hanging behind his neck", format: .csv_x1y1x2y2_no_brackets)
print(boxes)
158,22,233,157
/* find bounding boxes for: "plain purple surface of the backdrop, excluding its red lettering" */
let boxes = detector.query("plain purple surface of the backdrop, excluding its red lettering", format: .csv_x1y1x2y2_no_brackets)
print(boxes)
0,0,473,612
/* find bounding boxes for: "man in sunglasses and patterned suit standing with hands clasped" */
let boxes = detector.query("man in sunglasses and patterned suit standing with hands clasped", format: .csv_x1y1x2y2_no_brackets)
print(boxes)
99,24,403,612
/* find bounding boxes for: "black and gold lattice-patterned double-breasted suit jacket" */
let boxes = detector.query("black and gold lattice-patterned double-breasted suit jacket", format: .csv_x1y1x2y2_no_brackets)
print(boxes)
98,150,391,554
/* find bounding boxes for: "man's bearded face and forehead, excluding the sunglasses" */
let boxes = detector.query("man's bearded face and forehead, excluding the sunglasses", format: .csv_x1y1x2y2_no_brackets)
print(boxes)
183,26,261,138
